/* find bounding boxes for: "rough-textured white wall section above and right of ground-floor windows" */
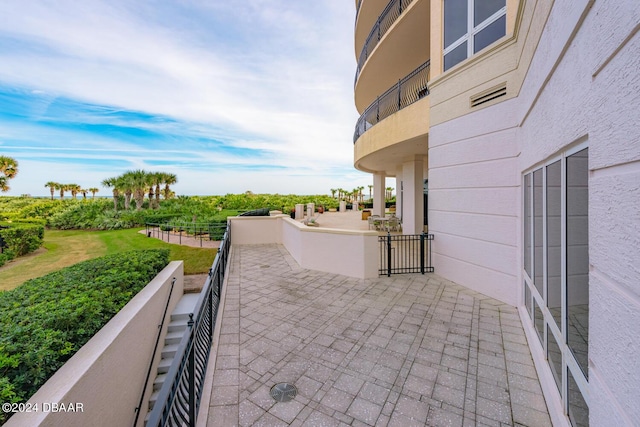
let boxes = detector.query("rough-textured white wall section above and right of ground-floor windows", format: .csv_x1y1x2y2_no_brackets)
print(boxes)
518,0,640,425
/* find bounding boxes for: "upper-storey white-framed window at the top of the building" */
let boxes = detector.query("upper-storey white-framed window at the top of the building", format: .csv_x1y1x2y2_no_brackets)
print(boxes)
444,0,507,71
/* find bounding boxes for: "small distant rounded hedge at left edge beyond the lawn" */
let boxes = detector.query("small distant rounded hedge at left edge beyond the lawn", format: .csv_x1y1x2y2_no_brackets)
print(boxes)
0,222,44,267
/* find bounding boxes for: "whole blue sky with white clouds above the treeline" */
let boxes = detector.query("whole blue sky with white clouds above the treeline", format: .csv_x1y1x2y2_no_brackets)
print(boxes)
0,0,380,196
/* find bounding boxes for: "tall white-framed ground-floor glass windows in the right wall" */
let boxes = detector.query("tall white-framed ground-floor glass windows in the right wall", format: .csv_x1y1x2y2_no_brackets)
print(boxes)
523,144,589,426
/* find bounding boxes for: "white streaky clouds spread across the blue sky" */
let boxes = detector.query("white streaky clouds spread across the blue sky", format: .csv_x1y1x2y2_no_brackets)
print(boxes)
0,0,370,193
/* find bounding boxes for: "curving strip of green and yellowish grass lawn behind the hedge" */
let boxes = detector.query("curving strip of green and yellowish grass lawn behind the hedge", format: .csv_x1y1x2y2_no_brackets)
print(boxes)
0,228,218,291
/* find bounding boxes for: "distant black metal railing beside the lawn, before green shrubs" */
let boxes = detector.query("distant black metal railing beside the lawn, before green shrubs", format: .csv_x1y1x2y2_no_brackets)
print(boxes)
145,221,227,247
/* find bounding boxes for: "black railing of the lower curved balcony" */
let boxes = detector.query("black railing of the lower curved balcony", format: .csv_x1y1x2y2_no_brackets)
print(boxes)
353,60,430,144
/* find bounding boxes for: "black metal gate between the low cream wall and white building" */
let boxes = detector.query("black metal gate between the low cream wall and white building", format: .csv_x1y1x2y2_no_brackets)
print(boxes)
378,233,434,276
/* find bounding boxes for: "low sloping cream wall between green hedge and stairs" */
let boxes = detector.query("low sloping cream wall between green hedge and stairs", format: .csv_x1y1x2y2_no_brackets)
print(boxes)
5,261,184,427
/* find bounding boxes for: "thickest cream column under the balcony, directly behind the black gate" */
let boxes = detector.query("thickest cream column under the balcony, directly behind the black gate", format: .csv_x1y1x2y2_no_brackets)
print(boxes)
402,158,424,234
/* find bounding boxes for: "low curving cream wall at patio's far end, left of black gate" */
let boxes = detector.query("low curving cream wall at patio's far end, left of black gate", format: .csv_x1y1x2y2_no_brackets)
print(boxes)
229,215,378,279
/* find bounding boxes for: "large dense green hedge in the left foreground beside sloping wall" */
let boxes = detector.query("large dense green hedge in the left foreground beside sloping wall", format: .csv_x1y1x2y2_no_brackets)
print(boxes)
0,249,169,424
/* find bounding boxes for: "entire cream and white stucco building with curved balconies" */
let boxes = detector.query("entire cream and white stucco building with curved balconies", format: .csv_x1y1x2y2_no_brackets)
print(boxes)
354,0,640,425
